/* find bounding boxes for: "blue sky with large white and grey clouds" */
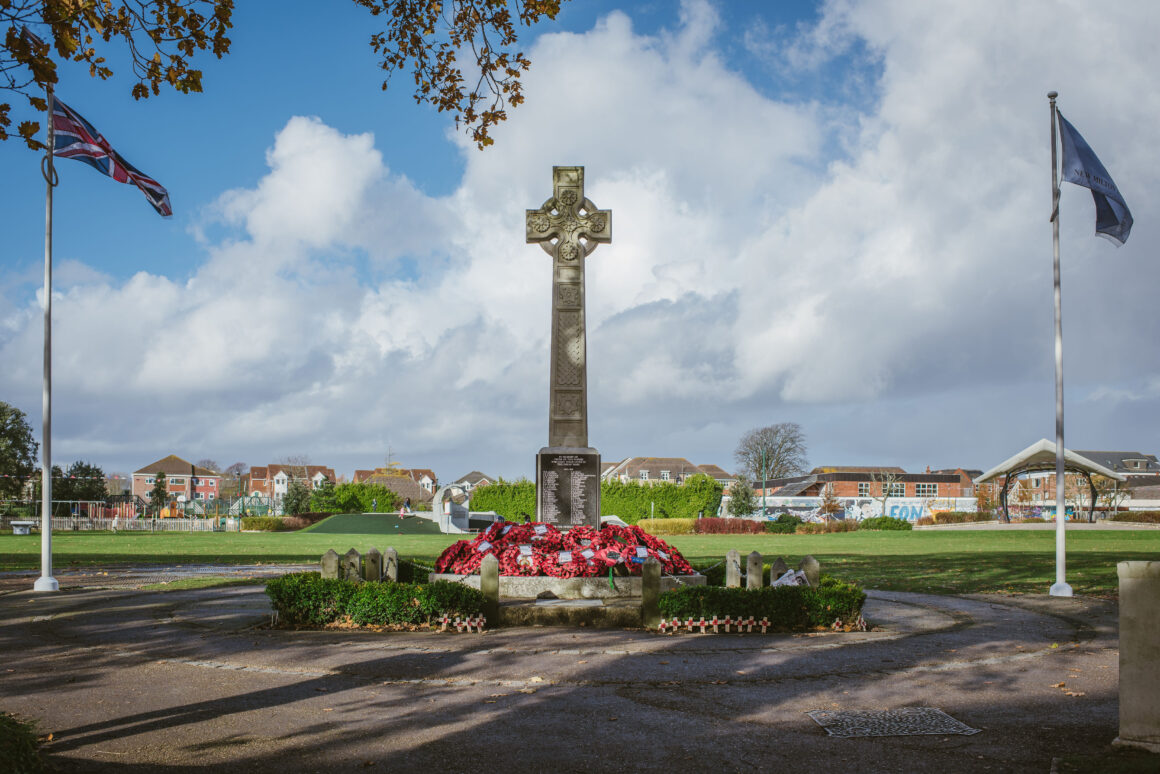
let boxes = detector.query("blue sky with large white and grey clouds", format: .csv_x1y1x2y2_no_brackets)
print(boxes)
0,0,1160,478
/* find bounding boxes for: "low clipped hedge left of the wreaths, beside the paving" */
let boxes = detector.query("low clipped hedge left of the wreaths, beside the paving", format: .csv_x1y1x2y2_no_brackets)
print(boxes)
266,572,484,625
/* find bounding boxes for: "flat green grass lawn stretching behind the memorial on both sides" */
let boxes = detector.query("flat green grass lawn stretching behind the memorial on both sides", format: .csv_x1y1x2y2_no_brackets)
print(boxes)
0,530,1160,596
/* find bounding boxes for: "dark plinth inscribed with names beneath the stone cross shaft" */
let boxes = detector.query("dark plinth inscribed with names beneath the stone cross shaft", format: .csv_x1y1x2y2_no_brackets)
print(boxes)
536,446,600,529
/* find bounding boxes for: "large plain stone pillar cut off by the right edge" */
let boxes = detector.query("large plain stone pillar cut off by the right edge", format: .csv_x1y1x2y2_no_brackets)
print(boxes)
1111,562,1160,752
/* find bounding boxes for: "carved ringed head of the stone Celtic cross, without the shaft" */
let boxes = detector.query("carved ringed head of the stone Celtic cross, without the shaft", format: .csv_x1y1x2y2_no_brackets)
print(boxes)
527,167,612,262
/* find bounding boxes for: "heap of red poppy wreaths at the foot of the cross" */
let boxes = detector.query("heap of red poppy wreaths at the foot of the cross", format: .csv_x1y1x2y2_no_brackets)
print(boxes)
435,521,695,578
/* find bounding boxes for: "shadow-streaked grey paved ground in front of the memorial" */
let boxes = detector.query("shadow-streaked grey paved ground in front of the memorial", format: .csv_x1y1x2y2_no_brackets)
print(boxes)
0,586,1118,774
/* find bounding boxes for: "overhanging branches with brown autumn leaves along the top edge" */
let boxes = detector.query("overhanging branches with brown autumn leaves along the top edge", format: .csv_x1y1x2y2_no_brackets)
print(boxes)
0,0,567,150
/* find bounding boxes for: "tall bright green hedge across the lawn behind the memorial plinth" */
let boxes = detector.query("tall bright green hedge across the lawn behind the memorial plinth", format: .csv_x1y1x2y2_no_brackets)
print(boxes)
471,475,722,525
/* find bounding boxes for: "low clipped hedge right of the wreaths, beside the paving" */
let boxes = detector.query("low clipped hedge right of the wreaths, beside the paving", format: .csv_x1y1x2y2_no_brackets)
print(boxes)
660,576,867,631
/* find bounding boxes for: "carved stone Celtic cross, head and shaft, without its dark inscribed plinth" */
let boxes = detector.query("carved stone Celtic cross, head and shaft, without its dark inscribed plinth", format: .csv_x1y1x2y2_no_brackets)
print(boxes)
528,167,612,447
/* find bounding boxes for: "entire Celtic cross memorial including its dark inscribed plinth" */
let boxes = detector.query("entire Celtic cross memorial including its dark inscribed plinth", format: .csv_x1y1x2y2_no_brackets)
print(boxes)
527,167,612,529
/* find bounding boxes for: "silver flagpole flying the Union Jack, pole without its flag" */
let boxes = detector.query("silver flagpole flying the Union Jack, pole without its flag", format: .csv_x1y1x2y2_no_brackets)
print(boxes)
32,84,60,592
